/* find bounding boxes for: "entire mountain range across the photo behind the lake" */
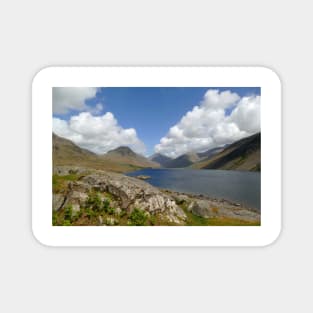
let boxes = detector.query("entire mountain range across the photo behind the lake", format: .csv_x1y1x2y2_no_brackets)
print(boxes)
53,133,261,172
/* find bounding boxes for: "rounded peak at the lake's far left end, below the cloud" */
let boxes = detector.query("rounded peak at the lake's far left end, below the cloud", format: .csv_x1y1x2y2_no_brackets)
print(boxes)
101,146,160,168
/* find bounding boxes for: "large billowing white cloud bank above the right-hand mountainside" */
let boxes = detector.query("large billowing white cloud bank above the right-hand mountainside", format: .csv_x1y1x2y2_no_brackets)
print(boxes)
155,89,260,157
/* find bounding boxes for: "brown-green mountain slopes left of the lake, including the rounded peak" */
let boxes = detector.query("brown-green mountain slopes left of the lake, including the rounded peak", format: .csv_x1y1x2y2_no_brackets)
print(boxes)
52,133,159,172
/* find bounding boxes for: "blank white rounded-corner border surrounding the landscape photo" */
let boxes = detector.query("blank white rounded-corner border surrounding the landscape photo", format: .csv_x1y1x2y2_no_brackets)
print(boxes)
32,67,281,246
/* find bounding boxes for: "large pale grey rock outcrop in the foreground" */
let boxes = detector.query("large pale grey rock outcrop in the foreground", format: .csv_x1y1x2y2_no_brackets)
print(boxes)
56,169,187,224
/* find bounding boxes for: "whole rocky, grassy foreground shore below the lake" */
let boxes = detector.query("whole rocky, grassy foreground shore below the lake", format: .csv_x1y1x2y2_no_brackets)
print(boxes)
53,166,260,226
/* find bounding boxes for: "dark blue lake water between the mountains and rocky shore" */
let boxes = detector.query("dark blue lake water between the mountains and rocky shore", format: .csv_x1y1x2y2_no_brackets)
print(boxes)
127,169,261,210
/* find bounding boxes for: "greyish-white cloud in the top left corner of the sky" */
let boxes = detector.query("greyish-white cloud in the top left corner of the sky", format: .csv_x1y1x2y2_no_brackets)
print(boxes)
52,87,97,114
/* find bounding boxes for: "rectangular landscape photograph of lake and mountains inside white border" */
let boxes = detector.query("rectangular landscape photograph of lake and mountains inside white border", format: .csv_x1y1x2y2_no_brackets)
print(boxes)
50,86,261,226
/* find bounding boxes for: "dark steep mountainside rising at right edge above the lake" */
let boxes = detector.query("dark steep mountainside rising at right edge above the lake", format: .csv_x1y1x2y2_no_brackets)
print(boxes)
192,133,261,171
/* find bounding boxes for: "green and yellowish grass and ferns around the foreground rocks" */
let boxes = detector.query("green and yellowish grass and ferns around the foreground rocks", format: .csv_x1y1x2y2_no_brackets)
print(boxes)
52,172,260,226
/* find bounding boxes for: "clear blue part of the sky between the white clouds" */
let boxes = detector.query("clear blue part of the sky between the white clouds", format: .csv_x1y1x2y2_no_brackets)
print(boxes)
54,87,261,155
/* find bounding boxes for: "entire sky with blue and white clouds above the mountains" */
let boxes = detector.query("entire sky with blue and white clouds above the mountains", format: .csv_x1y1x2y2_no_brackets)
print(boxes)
52,87,261,157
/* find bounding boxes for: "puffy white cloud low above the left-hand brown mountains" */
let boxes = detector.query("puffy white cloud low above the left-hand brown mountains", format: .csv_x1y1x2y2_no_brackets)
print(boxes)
53,112,146,154
